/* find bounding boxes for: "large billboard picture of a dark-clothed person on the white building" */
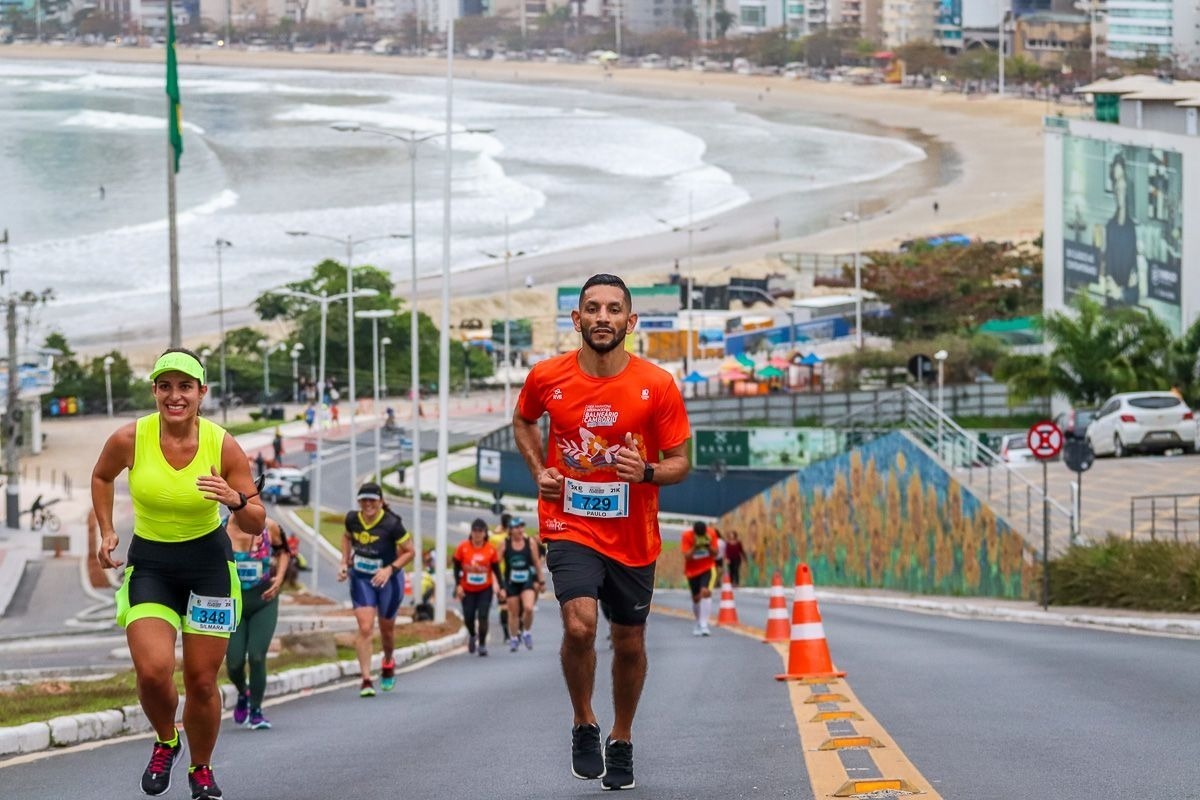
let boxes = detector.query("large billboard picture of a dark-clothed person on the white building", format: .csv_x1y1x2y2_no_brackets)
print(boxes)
1062,136,1183,333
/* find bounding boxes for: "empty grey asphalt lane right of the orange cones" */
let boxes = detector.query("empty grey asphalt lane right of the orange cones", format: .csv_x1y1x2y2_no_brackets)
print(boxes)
655,591,1200,800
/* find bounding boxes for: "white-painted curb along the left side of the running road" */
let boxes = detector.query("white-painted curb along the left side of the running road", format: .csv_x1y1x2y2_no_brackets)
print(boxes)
0,630,467,757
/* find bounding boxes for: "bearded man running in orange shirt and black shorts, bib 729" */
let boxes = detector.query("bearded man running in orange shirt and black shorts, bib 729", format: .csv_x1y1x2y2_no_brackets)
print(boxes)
512,273,691,789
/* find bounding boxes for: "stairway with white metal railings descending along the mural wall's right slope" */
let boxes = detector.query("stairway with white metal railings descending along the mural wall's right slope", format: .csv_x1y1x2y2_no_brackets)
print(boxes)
832,386,1079,552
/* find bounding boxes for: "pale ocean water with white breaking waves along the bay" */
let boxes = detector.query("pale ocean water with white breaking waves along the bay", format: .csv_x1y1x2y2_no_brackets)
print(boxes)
0,60,925,342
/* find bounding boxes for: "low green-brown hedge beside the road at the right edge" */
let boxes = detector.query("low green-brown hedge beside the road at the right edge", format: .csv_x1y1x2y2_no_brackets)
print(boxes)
1050,536,1200,613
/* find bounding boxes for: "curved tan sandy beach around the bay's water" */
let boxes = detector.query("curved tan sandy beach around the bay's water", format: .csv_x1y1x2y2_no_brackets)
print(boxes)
0,46,1051,365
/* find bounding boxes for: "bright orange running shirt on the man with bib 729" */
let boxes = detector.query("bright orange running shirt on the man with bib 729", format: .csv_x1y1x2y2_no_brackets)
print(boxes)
517,351,691,566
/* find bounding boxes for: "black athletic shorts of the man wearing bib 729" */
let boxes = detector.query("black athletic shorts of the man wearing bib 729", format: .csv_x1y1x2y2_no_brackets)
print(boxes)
546,541,654,625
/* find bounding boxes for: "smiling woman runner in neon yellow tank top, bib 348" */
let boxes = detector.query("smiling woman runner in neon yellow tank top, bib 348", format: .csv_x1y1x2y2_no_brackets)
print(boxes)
91,348,266,800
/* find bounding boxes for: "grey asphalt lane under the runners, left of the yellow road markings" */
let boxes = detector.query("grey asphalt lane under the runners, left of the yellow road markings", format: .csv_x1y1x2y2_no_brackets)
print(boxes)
0,600,812,800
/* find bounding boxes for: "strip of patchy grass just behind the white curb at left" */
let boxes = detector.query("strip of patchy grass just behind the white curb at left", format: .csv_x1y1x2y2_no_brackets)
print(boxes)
0,618,461,727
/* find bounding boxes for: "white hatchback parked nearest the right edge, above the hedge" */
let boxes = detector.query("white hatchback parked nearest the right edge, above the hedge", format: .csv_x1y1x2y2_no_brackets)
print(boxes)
1087,392,1196,458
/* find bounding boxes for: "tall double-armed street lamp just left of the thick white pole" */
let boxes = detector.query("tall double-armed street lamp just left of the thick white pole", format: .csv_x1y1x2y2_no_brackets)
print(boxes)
332,120,492,621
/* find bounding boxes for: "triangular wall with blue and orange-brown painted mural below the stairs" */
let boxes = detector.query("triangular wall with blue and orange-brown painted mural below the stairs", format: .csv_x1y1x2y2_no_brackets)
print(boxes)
700,433,1039,599
